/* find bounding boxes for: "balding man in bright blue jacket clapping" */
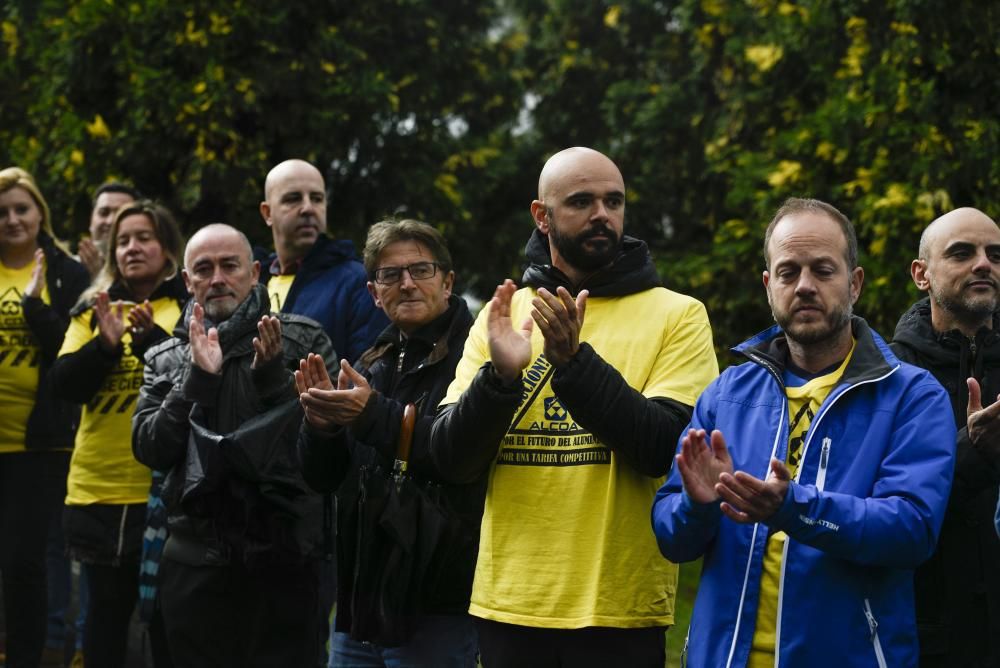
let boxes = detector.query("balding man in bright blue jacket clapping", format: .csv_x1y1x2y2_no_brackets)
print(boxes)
653,198,955,668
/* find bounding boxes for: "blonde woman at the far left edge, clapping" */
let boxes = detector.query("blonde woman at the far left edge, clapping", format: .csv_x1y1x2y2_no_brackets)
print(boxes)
0,167,89,668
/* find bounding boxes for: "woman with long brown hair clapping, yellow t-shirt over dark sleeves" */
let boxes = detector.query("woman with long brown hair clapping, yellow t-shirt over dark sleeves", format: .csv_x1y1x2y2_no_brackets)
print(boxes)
51,200,187,668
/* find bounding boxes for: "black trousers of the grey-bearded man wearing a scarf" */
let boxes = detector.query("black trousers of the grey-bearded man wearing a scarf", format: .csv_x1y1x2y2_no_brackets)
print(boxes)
159,558,322,668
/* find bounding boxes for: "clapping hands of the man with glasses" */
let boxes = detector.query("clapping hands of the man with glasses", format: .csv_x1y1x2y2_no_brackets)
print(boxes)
295,354,372,430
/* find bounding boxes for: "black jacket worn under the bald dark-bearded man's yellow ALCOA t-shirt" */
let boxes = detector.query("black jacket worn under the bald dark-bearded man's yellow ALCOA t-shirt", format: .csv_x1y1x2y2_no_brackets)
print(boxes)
431,230,692,482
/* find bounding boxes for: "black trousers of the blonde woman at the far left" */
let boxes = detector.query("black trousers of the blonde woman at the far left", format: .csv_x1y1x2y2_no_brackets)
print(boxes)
0,451,70,668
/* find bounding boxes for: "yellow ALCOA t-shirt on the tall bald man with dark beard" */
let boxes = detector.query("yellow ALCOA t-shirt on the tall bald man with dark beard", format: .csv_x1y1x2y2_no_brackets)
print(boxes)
442,288,718,629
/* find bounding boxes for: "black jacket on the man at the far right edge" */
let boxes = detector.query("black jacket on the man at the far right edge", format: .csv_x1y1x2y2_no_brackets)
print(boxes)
891,299,1000,668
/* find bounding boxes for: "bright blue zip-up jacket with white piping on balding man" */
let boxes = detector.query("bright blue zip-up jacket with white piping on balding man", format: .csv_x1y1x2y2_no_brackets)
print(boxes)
653,317,956,668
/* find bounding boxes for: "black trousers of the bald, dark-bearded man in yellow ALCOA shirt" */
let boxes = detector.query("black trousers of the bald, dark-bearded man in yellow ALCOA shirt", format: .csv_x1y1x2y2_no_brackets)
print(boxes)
475,618,668,668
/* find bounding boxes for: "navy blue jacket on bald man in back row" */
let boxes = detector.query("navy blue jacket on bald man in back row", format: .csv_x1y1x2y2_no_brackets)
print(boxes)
258,235,389,363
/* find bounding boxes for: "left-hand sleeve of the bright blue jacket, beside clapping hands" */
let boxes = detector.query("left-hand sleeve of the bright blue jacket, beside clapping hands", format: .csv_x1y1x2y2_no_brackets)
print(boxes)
652,380,722,563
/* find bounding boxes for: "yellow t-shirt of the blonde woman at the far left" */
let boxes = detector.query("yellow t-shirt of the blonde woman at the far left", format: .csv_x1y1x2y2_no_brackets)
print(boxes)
0,262,51,453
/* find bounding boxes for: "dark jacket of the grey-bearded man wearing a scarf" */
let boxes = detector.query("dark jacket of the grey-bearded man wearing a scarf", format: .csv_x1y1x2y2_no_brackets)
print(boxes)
132,285,336,568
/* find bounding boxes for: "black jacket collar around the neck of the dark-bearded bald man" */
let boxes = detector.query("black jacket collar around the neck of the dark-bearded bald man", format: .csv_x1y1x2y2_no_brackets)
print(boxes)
521,229,662,297
